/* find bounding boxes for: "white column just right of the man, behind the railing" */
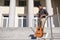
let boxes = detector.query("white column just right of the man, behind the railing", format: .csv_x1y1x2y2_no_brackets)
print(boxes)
46,0,54,27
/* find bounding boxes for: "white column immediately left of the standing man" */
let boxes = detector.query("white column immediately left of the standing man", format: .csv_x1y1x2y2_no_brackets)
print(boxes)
28,0,34,27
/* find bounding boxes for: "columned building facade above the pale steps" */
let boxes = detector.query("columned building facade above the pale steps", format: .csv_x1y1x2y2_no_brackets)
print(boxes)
0,0,60,27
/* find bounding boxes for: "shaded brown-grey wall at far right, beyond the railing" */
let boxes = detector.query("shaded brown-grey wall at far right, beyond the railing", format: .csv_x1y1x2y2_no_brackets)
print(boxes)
52,0,60,27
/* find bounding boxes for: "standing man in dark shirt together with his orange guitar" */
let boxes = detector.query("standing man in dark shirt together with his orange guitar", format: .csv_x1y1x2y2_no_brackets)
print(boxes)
34,4,48,38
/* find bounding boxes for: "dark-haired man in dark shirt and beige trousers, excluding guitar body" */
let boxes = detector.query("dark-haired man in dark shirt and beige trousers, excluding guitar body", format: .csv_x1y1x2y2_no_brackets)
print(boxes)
38,4,48,28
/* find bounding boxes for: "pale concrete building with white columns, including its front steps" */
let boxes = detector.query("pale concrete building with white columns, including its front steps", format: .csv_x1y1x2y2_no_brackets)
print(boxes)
0,0,60,40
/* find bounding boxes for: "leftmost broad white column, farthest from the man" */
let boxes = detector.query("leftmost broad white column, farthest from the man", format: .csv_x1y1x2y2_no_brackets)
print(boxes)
9,0,16,27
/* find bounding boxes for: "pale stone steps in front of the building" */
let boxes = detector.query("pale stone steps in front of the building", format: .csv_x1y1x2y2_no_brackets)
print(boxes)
0,27,60,40
